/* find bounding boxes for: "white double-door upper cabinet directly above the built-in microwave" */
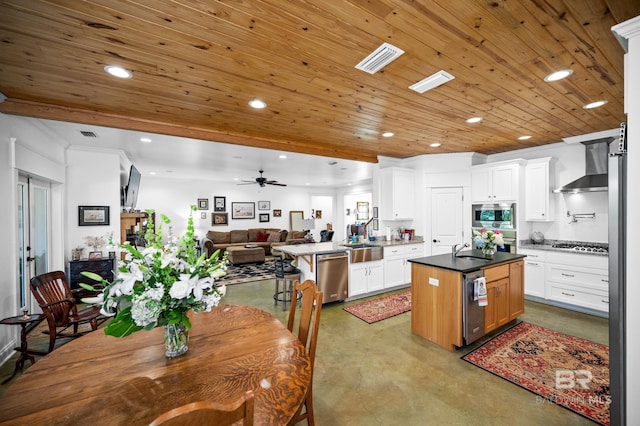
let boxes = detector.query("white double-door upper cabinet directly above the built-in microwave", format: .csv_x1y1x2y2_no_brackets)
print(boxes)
471,163,520,203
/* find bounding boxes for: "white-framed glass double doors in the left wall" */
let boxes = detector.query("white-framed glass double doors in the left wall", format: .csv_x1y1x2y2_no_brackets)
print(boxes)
17,175,51,312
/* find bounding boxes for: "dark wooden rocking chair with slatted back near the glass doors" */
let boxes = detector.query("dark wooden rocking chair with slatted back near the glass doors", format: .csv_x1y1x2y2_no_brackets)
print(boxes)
31,271,100,352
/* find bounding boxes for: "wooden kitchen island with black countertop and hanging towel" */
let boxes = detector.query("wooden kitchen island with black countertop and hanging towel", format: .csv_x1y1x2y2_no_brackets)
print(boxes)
409,250,526,351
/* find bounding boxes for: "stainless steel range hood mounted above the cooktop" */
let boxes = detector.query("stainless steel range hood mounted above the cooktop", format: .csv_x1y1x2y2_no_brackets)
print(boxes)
553,137,615,193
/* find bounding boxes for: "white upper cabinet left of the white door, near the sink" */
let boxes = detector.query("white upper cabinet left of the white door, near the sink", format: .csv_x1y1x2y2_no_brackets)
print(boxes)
380,167,415,220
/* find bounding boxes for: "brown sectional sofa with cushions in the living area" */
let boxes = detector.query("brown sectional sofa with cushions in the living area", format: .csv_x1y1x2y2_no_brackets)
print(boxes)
202,228,305,256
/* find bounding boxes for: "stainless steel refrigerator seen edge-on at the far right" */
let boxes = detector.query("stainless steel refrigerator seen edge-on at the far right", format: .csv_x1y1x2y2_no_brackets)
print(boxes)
609,123,627,425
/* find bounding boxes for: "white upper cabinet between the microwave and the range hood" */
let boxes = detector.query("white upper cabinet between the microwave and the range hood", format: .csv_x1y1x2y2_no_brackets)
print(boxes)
525,157,554,222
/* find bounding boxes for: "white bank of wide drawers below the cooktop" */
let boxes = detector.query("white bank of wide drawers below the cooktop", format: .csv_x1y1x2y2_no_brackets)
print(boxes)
545,252,609,312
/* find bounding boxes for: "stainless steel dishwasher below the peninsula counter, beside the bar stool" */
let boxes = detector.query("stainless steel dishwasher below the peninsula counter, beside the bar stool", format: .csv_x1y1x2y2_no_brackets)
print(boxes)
316,251,349,304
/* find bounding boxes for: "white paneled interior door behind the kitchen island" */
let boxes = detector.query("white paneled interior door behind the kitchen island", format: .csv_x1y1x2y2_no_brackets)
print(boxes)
431,187,463,255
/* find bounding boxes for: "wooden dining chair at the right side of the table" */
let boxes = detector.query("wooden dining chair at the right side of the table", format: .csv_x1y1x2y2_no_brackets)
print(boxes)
287,280,322,426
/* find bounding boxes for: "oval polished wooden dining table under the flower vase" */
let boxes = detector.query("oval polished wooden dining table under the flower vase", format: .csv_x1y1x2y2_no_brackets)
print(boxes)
0,305,311,426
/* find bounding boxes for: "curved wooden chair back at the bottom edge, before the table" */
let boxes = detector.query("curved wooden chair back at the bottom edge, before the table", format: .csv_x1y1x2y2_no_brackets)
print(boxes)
149,391,253,426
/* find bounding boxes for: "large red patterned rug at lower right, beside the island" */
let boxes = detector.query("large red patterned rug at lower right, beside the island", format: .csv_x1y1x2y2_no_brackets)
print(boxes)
462,322,611,425
